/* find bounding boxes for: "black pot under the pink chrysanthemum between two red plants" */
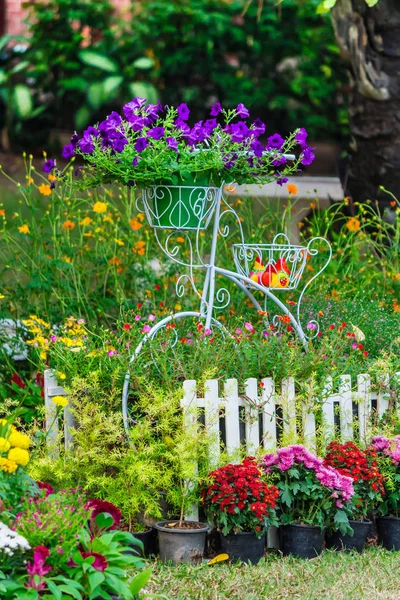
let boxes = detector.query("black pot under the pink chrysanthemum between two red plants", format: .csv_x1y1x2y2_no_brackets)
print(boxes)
279,523,324,558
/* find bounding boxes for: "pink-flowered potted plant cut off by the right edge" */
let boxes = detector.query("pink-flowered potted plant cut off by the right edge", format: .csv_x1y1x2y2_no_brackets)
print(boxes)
372,435,400,550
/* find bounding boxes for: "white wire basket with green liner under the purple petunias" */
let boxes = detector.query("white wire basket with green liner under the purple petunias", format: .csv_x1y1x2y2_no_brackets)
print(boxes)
141,185,221,230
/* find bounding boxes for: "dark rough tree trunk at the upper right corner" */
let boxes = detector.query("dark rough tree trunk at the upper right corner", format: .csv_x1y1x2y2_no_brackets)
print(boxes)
332,0,400,207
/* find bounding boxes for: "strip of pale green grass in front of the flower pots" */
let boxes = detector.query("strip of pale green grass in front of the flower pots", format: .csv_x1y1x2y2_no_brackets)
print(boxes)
146,548,400,600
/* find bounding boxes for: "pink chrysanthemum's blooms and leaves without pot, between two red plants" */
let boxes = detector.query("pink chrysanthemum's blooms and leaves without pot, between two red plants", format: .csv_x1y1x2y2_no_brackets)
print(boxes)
261,445,354,531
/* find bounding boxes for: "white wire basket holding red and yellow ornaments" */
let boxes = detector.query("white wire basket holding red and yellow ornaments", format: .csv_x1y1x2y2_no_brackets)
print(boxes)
232,234,311,290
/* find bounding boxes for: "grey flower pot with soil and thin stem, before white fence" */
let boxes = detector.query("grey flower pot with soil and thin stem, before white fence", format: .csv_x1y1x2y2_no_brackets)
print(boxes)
155,521,210,564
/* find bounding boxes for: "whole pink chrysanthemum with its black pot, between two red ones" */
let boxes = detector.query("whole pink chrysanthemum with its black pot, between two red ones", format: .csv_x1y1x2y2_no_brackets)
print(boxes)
263,445,354,558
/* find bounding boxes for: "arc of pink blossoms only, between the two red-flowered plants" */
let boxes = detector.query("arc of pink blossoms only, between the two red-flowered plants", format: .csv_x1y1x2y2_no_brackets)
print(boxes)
263,445,354,508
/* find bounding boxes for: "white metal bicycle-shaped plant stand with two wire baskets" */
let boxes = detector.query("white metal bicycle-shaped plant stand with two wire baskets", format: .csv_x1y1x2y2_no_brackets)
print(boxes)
122,179,332,430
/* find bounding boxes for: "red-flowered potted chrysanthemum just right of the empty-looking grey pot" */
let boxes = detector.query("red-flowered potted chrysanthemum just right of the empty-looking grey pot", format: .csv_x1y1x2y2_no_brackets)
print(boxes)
201,457,279,564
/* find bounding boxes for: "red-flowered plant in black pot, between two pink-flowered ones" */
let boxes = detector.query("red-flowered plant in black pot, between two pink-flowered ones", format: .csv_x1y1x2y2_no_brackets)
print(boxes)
324,441,385,553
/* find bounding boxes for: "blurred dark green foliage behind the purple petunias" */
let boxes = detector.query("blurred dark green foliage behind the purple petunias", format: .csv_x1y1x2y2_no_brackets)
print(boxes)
0,0,347,150
